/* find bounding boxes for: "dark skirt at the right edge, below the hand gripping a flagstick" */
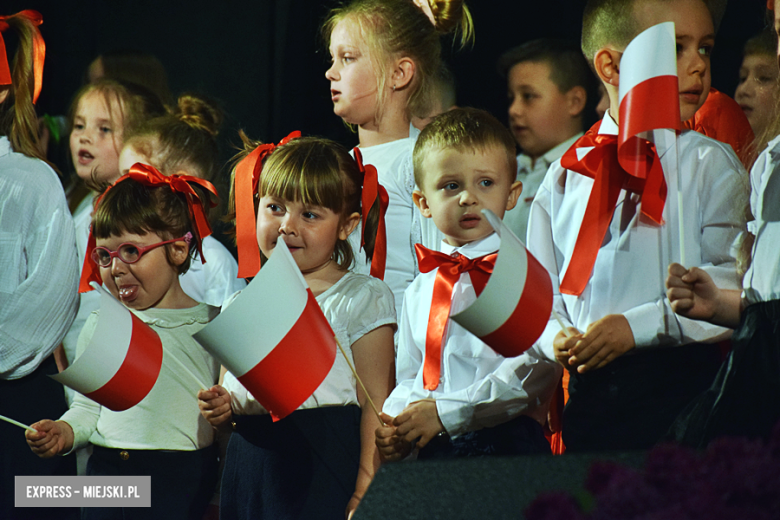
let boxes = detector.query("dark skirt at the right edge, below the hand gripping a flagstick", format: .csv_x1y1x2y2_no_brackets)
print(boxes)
669,300,780,448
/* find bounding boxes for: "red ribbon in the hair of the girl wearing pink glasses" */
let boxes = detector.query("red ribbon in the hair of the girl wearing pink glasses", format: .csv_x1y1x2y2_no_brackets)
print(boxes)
79,163,218,292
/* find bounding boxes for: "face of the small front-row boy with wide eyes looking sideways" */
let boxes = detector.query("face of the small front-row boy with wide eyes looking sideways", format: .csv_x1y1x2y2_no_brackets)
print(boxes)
413,146,523,247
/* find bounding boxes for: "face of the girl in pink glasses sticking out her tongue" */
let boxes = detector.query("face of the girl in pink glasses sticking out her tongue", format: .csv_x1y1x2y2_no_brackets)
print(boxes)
97,232,188,310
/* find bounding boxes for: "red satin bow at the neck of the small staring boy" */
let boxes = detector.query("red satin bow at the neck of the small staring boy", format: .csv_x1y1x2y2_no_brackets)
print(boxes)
414,244,498,390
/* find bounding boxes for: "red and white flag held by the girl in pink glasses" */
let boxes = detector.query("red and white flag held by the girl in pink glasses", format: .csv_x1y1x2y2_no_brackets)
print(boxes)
50,282,163,412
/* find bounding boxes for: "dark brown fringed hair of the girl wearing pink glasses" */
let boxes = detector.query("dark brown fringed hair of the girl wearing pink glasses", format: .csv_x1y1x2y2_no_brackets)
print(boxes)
92,178,209,274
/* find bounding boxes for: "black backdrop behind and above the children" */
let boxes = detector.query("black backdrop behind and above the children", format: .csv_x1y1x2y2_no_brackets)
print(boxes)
7,0,766,180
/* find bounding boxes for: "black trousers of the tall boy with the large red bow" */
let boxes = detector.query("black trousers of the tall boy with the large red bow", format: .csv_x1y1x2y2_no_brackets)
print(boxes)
563,344,721,453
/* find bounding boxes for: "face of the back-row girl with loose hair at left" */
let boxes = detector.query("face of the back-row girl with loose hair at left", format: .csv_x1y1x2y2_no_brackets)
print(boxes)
70,90,122,183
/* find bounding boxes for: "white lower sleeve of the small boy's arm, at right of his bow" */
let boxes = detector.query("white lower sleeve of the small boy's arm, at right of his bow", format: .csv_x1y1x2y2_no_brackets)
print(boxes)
436,348,563,436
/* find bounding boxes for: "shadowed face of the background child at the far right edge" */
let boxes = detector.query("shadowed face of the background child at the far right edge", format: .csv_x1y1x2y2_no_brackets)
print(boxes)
734,54,779,135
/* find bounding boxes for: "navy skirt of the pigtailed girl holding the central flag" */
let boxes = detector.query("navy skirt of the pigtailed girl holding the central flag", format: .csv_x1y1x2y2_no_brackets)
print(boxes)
220,405,361,520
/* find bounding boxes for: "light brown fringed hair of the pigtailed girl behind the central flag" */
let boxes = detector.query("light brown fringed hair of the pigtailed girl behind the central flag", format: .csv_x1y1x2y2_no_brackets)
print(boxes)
230,132,379,269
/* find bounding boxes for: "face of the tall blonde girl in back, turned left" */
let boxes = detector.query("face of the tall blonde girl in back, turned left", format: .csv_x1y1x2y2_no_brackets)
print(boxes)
325,19,378,125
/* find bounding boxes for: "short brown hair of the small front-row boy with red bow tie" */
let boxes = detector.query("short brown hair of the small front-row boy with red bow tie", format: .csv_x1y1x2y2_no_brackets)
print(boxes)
412,108,517,186
